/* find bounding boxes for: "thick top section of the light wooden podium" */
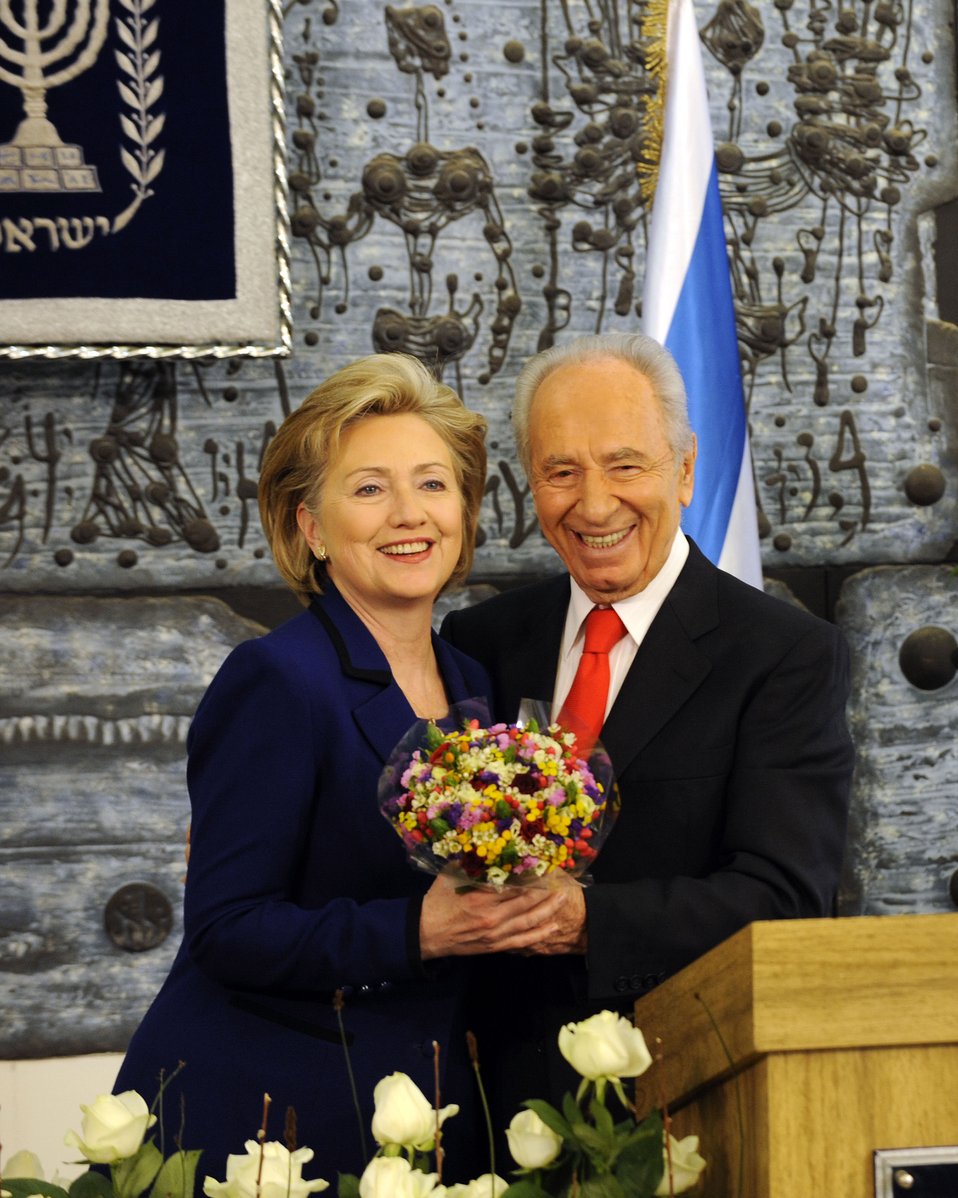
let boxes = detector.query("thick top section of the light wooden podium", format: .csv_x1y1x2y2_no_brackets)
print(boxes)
636,914,958,1111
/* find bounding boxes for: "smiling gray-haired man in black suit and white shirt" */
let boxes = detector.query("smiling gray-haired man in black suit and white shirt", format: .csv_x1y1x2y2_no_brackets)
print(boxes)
442,334,853,1118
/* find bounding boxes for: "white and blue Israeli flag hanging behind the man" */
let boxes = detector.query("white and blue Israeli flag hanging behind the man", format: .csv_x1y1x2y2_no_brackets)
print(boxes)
642,0,762,588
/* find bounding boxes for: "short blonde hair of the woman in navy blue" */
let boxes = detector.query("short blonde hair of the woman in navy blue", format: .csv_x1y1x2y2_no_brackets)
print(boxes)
259,353,486,603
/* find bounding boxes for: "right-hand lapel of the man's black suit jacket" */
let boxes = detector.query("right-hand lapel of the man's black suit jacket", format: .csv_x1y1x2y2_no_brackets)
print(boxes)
601,541,719,774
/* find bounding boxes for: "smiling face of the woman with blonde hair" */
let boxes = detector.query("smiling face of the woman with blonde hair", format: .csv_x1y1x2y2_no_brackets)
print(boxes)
297,413,462,610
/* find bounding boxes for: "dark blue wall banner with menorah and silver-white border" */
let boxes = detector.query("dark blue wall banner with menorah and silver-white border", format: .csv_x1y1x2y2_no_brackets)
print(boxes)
0,0,288,347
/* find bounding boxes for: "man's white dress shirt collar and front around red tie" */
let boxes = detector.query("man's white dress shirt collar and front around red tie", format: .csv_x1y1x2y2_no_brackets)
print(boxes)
552,530,689,719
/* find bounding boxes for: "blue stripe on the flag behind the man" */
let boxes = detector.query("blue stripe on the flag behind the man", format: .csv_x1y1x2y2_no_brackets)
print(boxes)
666,163,746,562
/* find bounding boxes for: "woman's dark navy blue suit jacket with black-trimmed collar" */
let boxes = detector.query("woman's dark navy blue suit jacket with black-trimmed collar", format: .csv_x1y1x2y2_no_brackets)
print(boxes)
116,587,487,1184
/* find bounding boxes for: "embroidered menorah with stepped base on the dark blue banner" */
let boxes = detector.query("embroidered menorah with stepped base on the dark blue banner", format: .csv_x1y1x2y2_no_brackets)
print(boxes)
0,0,109,192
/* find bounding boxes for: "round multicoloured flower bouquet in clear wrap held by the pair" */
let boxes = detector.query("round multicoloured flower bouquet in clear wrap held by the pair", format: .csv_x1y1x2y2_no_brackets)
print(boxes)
380,703,618,889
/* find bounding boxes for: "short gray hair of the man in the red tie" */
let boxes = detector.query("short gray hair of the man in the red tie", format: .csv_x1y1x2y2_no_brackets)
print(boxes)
513,333,693,474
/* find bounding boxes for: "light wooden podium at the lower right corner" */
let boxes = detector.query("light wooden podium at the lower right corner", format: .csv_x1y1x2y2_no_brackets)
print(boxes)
636,914,958,1198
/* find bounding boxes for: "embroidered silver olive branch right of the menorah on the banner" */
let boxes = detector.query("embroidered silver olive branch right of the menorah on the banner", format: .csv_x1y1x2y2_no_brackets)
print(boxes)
113,0,166,232
